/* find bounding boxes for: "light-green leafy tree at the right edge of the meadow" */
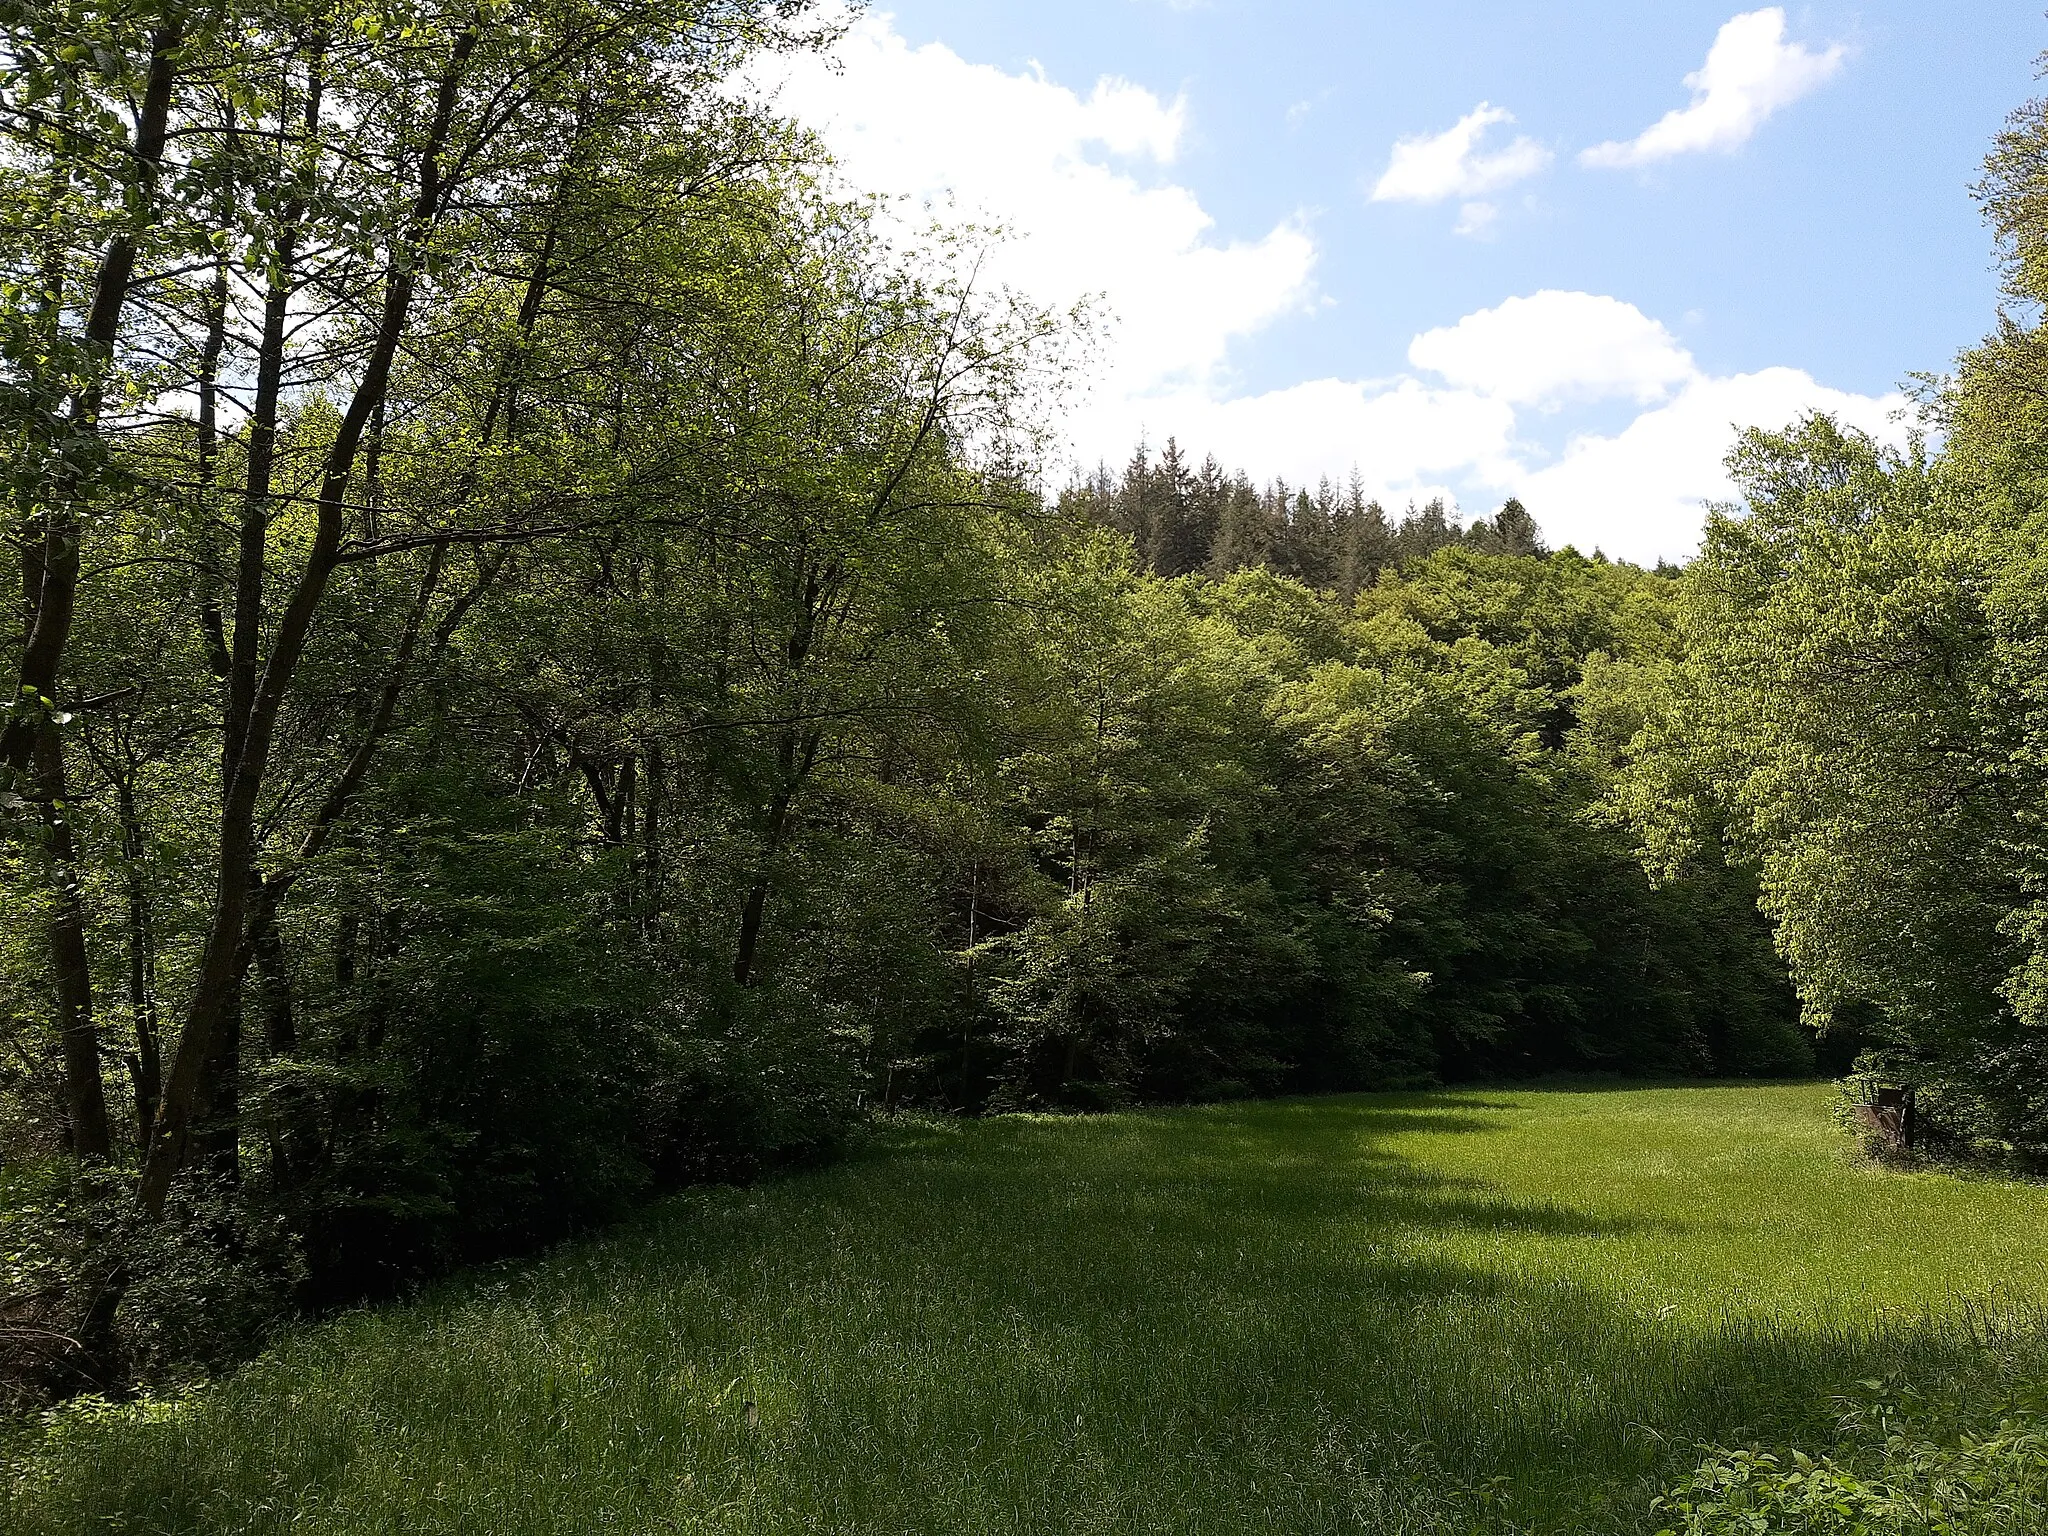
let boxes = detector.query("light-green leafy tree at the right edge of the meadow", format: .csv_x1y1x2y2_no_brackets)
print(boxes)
1622,420,2048,1157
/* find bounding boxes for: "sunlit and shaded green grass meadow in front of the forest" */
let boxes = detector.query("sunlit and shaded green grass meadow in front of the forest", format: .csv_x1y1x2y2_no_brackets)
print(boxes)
0,1085,2048,1536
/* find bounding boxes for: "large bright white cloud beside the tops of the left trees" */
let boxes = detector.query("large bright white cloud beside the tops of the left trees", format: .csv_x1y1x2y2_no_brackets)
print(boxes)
774,14,1315,415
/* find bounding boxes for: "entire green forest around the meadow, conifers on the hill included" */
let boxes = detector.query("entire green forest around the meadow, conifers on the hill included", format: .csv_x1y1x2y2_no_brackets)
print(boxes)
0,0,2048,1482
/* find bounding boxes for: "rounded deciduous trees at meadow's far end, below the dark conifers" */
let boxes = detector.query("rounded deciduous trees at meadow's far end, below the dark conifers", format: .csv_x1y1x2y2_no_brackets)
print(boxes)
909,549,1812,1108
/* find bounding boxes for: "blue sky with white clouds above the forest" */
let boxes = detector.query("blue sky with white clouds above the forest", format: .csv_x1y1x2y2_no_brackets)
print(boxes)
764,0,2048,561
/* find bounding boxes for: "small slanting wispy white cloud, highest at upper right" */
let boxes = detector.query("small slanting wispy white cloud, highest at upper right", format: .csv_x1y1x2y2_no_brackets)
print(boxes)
1579,6,1847,168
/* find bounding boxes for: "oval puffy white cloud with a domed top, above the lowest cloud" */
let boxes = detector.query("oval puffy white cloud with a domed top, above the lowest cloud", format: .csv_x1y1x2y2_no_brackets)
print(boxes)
1409,289,1698,408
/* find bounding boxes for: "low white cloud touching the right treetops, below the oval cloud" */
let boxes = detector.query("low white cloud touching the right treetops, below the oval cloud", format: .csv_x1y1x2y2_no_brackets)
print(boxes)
1513,369,1907,563
